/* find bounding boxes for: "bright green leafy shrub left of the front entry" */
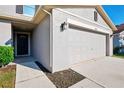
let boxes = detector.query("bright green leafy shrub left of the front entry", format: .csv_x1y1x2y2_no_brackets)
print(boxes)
0,46,14,66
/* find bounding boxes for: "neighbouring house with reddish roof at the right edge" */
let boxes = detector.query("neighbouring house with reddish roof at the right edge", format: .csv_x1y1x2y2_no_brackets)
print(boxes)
113,24,124,53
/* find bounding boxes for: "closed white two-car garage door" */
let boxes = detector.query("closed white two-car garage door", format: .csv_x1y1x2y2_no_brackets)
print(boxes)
68,27,106,64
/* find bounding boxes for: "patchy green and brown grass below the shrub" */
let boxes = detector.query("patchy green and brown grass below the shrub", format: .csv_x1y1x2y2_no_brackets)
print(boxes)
0,67,16,88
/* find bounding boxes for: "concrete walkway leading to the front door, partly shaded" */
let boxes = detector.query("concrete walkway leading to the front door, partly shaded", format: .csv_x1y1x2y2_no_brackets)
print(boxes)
15,57,55,88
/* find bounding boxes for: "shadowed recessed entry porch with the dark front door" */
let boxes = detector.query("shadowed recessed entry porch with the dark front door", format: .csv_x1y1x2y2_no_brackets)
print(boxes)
12,23,37,64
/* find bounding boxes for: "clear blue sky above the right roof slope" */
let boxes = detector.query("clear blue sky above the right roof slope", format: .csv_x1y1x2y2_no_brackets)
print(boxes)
102,5,124,25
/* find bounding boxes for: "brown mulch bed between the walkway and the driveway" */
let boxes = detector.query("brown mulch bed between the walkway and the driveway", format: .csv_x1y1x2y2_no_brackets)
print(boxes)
36,62,85,88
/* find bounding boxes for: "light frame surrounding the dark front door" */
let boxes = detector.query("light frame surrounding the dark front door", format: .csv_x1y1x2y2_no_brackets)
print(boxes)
15,32,31,57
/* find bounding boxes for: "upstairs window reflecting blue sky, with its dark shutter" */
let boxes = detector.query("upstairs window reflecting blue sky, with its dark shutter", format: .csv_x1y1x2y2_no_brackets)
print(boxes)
16,5,35,16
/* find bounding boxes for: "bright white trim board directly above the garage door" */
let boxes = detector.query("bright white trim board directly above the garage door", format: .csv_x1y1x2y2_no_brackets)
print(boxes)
67,18,109,34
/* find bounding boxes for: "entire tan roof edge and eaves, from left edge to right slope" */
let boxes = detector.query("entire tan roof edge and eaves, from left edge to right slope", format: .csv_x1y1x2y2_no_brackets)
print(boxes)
0,5,117,31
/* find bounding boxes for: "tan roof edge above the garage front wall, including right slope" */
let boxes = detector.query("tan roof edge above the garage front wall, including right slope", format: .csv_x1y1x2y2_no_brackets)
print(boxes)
42,5,117,31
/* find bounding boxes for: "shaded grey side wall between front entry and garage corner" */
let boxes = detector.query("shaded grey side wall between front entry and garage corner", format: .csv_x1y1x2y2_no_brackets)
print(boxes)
32,16,52,71
